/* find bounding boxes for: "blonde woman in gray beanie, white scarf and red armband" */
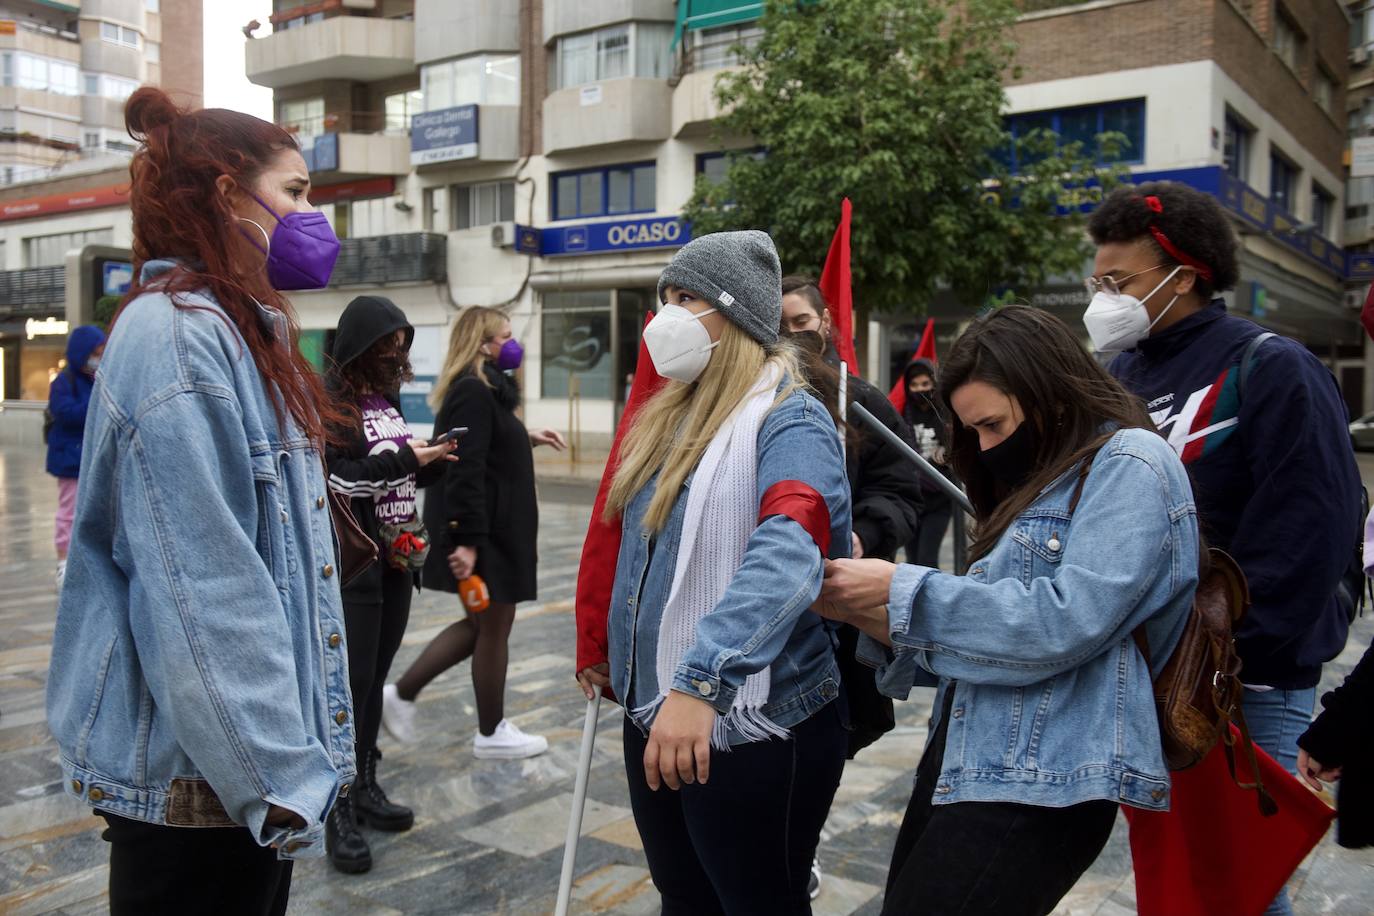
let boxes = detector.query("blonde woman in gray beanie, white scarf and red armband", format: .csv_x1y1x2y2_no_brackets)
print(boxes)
578,232,849,913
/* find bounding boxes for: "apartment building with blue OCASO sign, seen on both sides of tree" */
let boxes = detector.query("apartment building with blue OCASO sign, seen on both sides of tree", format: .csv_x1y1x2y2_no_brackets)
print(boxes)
247,0,1374,433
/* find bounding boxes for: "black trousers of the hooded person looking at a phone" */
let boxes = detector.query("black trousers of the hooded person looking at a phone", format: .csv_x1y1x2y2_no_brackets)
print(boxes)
344,567,415,773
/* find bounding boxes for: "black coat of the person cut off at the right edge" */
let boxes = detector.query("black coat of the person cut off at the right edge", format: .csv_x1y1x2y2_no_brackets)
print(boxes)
1297,634,1374,849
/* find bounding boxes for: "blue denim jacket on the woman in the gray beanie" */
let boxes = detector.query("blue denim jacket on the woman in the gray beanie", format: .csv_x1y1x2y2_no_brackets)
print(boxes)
607,391,849,744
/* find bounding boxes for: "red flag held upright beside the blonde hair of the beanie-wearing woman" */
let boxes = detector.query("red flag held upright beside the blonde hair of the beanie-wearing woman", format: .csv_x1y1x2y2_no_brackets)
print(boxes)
573,312,668,696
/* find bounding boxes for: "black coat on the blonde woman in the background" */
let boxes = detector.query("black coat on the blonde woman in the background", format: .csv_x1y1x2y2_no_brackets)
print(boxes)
422,365,539,604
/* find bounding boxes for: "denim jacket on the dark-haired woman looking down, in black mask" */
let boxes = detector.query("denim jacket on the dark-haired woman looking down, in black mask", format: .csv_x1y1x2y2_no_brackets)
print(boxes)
860,428,1198,809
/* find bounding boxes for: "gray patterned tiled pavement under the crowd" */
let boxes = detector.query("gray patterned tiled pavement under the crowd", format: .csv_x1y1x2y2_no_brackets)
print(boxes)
0,439,1374,916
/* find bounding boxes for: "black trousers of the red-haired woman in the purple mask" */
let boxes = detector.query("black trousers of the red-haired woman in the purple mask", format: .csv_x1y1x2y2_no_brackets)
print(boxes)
100,812,291,916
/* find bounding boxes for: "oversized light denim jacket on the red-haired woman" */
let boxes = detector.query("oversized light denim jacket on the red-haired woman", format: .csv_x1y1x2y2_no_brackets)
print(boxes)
48,261,354,857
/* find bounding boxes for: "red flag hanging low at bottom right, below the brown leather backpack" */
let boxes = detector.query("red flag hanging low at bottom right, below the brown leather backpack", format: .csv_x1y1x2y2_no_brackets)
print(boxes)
1124,726,1336,916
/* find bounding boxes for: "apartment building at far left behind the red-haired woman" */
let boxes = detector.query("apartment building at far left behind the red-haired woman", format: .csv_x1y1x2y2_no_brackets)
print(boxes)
0,0,205,400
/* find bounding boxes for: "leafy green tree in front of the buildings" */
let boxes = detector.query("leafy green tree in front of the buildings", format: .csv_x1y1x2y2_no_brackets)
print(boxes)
686,0,1124,313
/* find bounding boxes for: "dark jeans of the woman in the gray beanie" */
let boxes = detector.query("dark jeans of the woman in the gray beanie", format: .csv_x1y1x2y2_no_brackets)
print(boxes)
625,702,848,916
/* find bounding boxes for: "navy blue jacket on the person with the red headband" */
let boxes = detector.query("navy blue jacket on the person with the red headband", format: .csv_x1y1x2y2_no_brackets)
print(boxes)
1110,299,1362,689
